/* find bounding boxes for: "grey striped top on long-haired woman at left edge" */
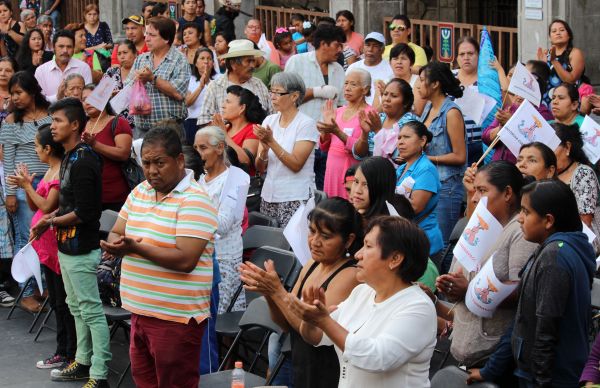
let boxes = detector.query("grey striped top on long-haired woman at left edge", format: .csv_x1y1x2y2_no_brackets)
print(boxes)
0,116,52,195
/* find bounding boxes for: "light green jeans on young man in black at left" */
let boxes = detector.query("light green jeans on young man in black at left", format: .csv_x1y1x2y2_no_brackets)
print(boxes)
58,249,111,379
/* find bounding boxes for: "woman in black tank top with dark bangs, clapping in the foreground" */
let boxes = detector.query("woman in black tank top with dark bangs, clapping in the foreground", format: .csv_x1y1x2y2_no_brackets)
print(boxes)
240,197,362,388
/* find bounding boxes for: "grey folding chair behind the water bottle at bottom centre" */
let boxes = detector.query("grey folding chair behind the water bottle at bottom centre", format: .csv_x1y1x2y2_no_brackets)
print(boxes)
200,297,281,388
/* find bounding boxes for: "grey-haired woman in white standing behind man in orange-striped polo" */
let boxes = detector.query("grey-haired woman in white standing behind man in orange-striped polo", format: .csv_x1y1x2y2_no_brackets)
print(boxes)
194,126,250,314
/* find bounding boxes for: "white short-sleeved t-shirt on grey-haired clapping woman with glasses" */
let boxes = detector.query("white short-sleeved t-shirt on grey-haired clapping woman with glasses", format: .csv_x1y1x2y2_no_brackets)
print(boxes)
261,112,319,203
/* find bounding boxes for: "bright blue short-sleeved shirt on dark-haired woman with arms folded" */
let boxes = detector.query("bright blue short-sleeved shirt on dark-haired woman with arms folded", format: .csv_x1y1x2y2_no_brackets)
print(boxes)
396,153,444,255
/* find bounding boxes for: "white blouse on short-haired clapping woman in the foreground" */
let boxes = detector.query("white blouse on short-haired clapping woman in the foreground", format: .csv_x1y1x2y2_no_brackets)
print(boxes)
319,284,437,388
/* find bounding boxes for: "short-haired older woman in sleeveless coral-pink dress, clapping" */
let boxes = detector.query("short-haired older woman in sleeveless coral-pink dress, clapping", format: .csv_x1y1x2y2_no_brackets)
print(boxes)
317,69,375,198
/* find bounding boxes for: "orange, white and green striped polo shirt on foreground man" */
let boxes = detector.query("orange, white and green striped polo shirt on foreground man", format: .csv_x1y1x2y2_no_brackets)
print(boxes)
119,170,217,324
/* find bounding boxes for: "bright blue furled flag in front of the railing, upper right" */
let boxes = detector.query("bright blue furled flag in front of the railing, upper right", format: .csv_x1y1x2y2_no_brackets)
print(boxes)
477,27,502,162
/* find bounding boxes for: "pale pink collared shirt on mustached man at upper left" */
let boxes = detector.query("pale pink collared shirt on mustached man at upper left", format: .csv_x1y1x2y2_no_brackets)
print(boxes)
35,58,92,102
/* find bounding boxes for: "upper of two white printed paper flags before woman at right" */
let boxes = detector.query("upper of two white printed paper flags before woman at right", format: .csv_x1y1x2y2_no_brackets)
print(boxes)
452,197,502,272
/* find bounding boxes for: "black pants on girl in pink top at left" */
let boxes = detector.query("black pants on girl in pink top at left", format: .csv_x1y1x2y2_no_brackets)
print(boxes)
42,264,77,360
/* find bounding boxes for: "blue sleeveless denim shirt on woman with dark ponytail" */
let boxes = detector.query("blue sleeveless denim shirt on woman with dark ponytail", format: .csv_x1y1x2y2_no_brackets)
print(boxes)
421,97,467,182
